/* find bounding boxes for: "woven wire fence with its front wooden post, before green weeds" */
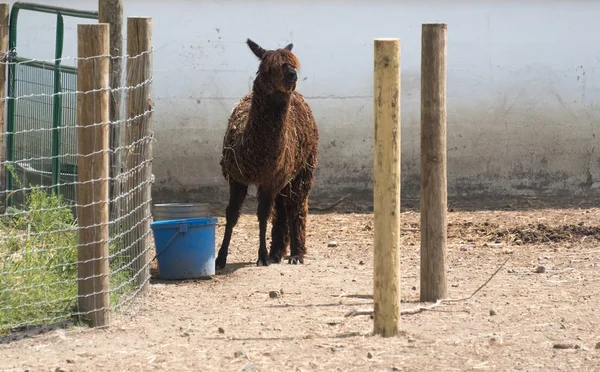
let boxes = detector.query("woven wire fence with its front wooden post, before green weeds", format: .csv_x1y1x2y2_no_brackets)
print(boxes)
0,44,154,336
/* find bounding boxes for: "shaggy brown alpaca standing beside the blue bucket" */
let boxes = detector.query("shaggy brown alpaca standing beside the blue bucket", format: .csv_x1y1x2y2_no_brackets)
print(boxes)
216,39,319,269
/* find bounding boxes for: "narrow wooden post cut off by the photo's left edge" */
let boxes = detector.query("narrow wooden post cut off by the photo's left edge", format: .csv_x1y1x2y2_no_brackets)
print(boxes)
0,3,10,192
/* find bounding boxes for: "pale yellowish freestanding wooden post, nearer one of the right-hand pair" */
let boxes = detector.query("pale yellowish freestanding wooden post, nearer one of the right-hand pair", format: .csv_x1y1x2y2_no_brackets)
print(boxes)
373,39,400,337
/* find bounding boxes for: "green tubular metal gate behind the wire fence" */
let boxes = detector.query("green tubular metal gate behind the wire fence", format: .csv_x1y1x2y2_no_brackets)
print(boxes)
6,2,98,205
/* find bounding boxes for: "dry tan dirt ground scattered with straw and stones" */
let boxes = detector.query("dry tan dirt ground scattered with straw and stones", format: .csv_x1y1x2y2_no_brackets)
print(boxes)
0,201,600,372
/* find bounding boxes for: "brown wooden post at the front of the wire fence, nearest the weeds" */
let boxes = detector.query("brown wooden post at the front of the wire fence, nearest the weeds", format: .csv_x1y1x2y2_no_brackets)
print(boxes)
77,23,110,327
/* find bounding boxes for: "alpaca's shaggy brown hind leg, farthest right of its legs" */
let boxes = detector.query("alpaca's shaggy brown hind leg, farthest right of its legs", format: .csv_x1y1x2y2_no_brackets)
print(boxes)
288,170,313,265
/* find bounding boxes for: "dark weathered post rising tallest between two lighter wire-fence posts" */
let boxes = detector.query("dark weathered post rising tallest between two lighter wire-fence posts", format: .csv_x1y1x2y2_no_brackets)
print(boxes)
98,0,123,218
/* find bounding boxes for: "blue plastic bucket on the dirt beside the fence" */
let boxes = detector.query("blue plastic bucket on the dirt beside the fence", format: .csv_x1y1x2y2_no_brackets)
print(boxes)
150,218,218,280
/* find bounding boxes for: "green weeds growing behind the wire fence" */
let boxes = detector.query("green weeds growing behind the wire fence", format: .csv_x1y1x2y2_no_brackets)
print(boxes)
0,167,141,335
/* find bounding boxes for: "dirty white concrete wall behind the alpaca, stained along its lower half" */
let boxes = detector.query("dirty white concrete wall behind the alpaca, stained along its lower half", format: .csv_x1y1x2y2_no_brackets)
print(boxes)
8,0,600,200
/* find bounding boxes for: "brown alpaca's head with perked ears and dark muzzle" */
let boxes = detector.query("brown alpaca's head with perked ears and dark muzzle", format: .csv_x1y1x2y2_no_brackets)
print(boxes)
246,39,300,93
